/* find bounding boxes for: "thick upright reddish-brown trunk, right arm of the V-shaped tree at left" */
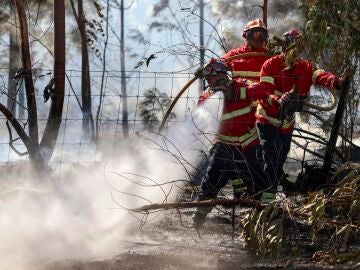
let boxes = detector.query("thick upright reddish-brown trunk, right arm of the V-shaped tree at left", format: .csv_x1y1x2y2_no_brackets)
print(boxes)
40,0,66,161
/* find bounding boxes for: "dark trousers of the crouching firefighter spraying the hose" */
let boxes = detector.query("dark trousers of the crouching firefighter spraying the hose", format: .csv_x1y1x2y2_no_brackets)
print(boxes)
200,143,264,199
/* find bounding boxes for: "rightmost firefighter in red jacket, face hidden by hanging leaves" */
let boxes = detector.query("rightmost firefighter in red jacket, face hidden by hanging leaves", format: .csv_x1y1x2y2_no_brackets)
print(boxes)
244,29,343,200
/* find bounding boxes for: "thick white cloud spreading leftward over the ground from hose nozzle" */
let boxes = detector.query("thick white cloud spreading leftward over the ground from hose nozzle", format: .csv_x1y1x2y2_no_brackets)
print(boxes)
0,104,216,270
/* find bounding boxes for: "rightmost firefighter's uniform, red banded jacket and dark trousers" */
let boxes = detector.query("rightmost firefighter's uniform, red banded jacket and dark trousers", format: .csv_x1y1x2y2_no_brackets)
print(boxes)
240,55,339,190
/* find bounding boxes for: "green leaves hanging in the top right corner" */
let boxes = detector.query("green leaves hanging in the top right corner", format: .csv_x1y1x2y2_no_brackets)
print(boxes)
303,0,360,72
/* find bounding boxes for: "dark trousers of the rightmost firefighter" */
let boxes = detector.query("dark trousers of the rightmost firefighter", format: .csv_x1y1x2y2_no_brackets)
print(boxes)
256,123,292,191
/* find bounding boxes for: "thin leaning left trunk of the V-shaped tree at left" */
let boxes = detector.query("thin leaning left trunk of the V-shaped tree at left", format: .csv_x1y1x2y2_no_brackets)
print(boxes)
13,0,43,163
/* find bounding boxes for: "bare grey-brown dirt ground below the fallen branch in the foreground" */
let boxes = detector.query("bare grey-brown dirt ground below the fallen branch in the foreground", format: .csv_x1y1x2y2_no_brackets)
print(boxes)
37,209,355,270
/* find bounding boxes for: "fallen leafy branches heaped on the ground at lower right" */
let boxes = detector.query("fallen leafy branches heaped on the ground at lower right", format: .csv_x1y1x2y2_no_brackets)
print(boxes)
242,165,360,265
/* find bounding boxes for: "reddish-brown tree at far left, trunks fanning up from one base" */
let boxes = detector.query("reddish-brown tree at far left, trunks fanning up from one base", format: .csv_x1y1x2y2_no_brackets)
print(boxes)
0,0,65,167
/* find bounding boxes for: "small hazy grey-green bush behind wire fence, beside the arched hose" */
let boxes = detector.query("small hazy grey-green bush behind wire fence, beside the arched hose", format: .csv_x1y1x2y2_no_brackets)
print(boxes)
139,88,176,130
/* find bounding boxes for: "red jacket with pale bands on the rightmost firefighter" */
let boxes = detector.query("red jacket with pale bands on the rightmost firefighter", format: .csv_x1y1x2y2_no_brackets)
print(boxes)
242,55,339,133
